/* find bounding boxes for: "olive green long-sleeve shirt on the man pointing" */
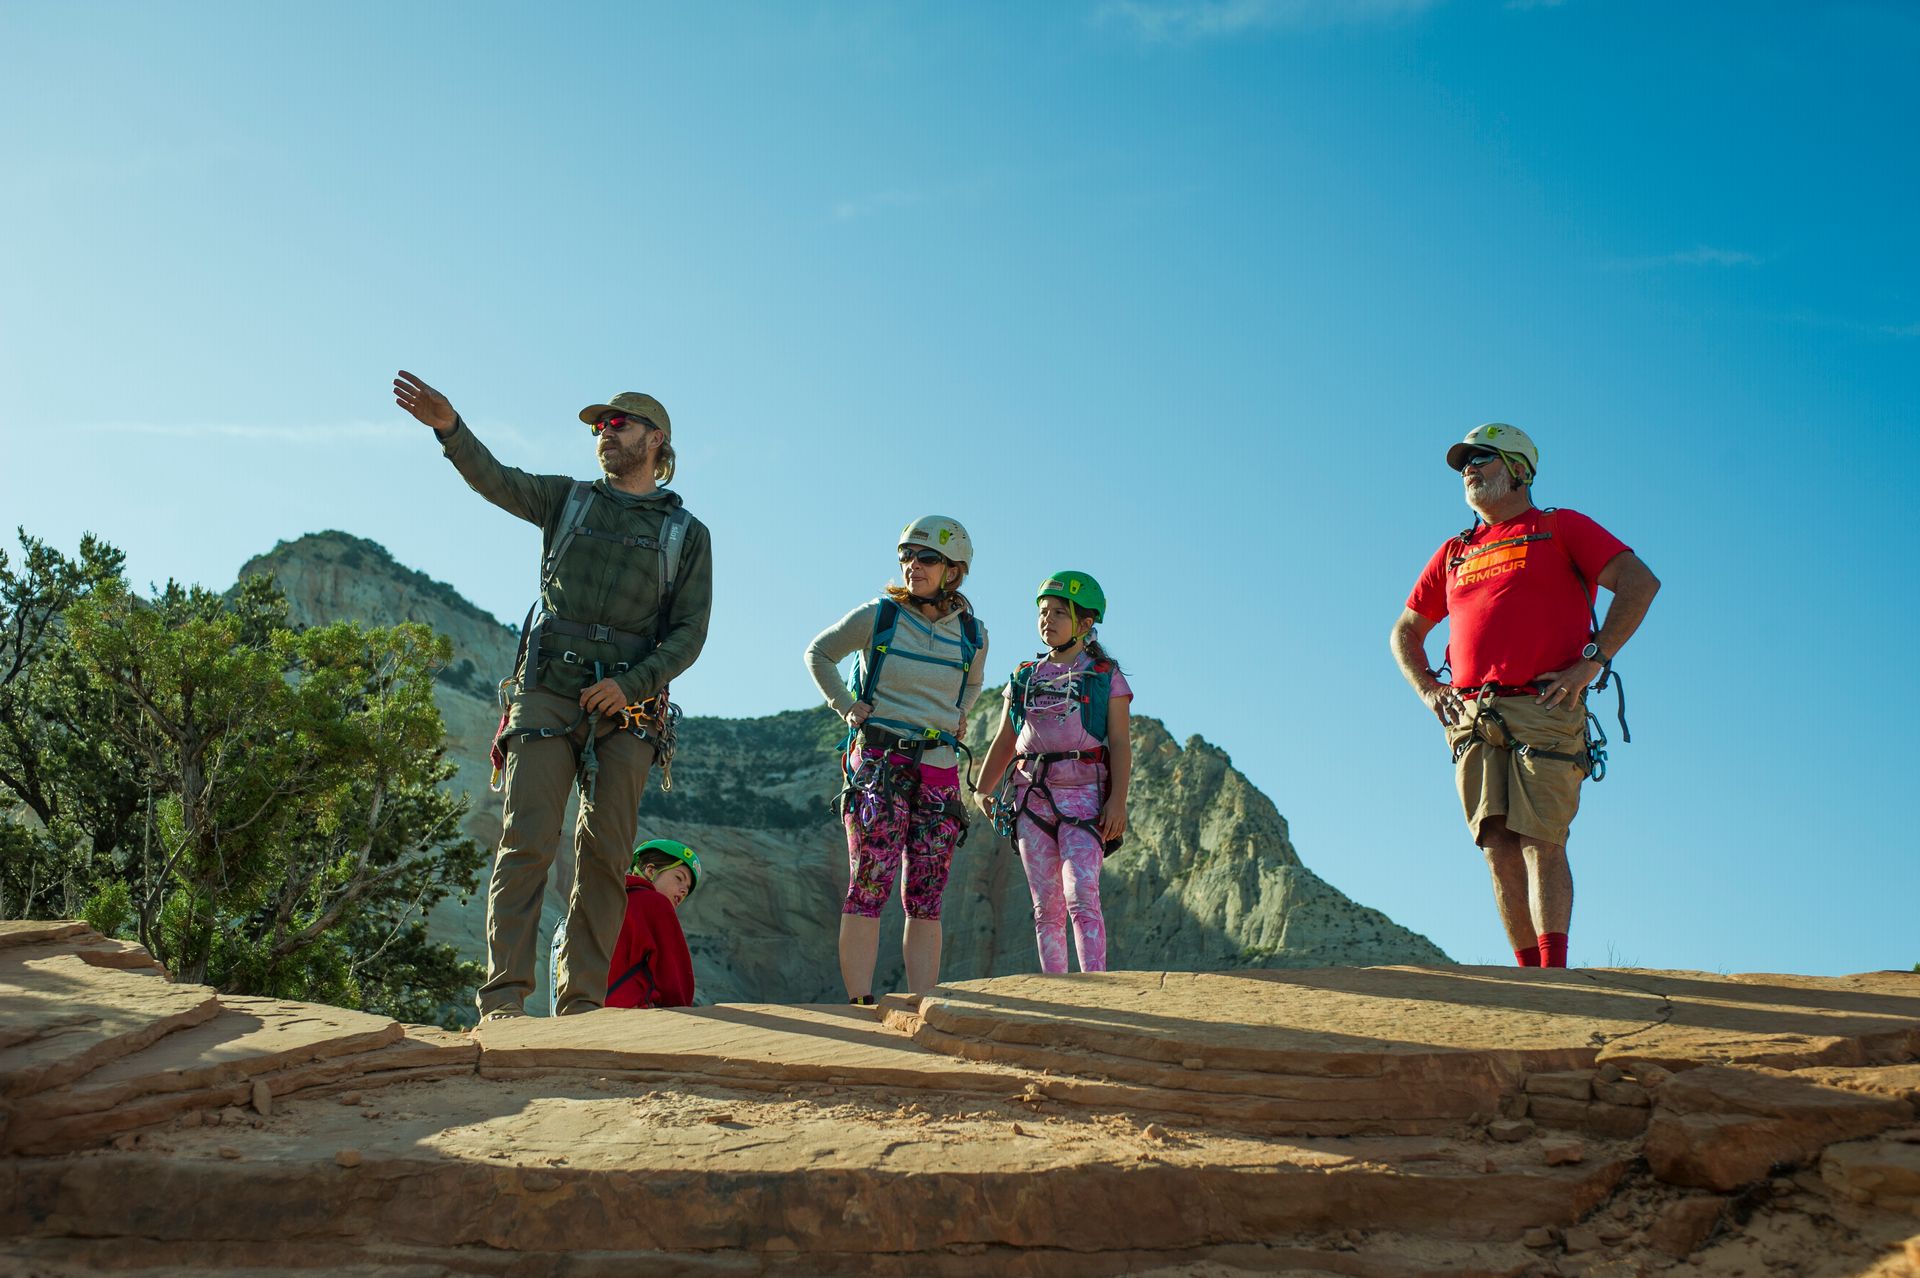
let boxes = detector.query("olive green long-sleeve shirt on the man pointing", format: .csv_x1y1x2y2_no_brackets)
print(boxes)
442,420,714,702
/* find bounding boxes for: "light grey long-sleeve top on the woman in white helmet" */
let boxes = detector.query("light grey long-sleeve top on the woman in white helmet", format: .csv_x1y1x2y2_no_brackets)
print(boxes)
806,599,987,768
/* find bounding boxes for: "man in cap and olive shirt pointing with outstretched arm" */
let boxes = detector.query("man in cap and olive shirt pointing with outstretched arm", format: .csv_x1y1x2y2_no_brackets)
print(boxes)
394,372,712,1019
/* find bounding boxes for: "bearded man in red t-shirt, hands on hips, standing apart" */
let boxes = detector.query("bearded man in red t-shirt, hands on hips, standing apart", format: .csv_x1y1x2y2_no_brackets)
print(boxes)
1392,422,1661,967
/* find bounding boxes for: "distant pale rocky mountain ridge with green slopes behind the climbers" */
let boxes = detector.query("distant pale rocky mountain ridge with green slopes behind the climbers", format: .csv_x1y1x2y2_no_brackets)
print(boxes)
240,532,1450,1002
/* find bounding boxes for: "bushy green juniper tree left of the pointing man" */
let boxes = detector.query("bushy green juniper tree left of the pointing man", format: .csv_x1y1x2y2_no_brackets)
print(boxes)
0,533,482,1019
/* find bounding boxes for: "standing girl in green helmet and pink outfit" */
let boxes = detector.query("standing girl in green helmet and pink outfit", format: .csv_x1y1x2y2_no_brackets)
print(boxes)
975,572,1133,971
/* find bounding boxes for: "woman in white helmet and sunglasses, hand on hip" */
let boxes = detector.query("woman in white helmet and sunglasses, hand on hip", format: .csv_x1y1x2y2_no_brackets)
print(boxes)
806,514,987,1004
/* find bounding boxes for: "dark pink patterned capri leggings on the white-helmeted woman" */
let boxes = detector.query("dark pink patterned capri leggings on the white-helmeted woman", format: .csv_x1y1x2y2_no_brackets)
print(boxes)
841,756,964,919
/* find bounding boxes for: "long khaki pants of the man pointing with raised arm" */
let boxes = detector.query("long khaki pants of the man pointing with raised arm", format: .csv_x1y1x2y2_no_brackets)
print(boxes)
476,689,653,1015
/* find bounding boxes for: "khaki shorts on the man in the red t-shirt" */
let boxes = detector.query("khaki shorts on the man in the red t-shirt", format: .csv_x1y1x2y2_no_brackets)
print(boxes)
1446,697,1586,846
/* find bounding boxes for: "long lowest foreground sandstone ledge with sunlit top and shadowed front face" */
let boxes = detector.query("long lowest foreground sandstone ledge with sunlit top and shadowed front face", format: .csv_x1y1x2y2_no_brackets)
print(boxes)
0,1075,1626,1257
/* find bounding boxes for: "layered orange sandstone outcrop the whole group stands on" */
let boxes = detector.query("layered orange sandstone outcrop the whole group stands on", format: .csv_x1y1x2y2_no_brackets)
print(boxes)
0,923,1920,1278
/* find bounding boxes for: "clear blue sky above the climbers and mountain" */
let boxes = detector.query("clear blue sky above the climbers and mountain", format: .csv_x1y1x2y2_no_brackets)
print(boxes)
0,0,1920,973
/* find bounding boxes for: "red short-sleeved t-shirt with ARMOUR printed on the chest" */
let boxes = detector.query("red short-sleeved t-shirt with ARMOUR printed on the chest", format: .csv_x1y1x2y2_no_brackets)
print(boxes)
1407,509,1628,689
